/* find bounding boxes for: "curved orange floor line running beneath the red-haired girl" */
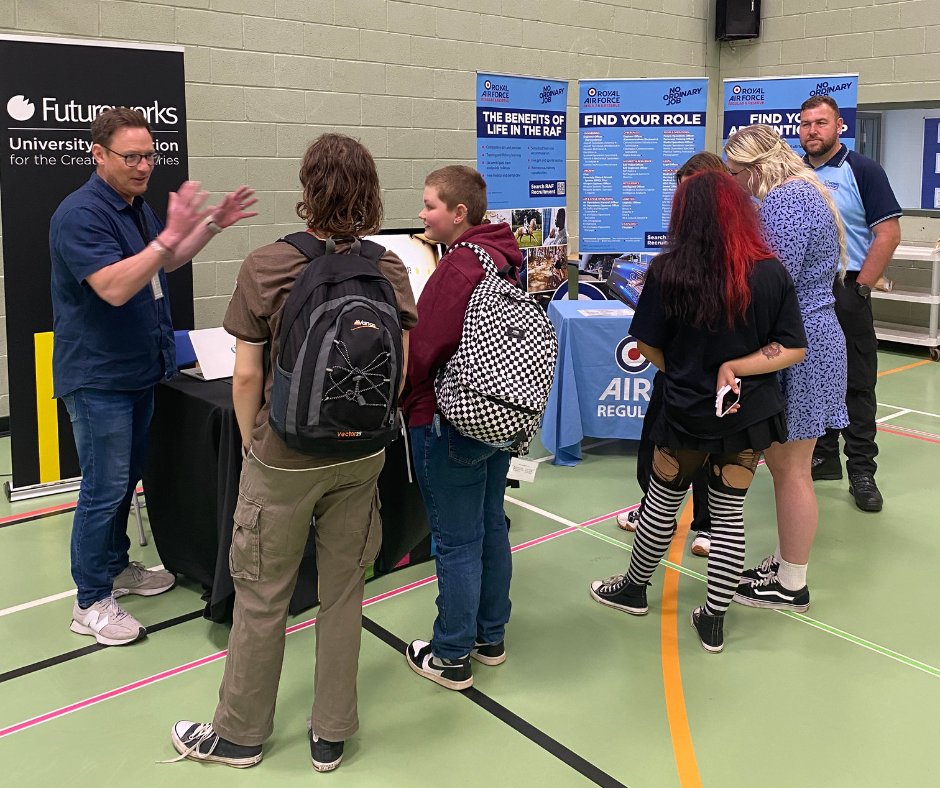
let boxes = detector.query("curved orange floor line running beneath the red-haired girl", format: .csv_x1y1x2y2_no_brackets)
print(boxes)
660,496,702,788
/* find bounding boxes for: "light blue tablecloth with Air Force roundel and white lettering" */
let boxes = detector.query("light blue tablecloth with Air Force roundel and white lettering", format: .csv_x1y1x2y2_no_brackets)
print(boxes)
541,301,656,465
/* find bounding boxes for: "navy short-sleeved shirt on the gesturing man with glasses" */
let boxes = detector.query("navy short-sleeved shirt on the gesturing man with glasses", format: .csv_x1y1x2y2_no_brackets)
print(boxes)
49,173,176,397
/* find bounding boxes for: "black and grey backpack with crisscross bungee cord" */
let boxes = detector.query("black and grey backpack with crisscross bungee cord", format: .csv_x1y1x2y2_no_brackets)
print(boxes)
268,232,403,458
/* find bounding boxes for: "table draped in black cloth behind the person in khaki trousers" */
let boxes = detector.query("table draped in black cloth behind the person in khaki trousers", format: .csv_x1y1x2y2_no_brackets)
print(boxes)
143,375,429,621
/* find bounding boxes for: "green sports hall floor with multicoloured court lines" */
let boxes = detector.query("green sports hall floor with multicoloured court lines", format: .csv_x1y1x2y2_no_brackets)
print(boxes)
0,349,940,788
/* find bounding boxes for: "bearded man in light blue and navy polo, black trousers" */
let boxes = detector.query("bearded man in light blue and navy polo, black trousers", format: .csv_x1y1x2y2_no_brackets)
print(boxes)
800,96,901,512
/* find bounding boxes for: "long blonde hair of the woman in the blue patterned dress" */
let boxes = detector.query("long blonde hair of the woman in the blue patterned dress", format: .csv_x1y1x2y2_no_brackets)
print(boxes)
725,125,848,279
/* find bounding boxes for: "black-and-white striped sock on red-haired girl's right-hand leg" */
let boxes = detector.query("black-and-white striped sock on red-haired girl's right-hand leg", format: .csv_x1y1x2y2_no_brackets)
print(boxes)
705,487,746,616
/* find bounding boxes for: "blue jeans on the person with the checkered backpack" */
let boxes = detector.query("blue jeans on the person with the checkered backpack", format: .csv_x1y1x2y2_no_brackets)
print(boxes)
410,416,512,659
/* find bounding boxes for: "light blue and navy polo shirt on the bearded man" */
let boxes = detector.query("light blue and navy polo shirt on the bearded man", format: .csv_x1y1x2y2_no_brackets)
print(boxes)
803,145,902,271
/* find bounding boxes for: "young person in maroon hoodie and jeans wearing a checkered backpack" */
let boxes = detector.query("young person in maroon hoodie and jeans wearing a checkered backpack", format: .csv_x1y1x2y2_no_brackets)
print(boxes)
401,166,556,690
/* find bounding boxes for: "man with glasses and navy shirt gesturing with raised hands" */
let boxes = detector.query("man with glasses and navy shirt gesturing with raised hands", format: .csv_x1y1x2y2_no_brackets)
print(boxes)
49,107,255,646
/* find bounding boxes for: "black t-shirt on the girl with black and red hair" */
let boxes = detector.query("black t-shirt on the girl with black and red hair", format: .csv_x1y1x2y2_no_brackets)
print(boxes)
630,258,807,438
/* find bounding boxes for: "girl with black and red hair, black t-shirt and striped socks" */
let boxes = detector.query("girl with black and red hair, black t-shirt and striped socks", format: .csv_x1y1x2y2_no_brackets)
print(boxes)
591,172,806,652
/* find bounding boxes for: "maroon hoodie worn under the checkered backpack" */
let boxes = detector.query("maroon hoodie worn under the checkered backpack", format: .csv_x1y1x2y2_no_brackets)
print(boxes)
401,222,522,427
